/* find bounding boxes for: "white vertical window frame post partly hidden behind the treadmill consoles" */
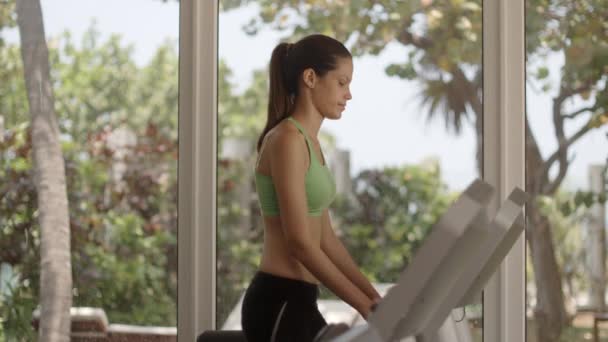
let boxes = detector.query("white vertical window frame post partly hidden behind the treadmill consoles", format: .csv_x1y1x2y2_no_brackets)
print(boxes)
483,0,526,342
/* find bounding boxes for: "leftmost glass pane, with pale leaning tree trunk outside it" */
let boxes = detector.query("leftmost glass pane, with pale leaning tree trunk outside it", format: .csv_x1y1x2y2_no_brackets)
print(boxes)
0,0,179,341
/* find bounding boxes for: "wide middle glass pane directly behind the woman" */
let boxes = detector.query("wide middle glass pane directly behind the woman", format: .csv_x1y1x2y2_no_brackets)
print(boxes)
217,0,483,341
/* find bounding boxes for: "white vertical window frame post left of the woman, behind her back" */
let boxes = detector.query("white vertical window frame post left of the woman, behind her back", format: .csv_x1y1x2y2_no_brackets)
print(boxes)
177,0,218,342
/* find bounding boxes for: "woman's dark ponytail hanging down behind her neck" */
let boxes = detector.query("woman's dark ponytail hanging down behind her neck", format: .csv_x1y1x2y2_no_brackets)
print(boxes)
257,43,295,152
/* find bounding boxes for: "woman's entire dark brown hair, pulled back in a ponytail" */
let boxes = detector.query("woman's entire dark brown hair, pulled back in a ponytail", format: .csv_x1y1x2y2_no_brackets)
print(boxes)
257,34,352,152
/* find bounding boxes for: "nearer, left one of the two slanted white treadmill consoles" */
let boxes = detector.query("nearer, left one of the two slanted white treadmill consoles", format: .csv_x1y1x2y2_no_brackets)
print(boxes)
368,180,494,341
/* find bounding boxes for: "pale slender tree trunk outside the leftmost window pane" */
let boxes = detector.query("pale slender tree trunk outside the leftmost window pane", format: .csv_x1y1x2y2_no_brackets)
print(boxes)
17,0,72,342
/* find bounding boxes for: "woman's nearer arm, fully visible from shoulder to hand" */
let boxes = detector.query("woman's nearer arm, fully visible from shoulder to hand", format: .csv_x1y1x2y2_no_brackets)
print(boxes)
270,131,373,317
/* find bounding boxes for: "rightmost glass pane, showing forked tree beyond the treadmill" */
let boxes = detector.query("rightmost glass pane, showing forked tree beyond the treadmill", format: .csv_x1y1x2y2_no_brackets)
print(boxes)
526,0,608,342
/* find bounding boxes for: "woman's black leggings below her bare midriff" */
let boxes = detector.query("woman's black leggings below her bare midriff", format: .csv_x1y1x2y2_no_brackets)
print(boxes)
241,271,327,342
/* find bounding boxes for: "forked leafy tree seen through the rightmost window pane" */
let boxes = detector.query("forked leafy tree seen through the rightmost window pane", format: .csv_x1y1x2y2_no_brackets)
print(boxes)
526,0,608,341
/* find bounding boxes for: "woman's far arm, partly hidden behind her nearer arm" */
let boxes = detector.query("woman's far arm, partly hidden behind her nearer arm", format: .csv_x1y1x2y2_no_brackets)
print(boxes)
321,209,380,302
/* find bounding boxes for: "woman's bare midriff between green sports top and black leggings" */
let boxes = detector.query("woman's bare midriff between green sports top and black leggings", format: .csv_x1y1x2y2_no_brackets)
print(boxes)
260,216,321,284
